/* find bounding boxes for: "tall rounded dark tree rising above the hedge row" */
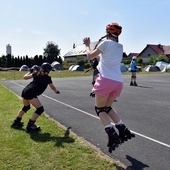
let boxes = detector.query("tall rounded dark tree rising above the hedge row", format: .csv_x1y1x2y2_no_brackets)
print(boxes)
43,41,60,63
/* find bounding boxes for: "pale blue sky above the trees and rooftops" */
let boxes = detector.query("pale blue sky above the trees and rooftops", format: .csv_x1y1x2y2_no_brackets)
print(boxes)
0,0,170,57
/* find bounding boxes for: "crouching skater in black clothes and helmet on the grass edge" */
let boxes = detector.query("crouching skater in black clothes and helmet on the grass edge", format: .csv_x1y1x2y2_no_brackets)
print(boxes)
11,63,60,132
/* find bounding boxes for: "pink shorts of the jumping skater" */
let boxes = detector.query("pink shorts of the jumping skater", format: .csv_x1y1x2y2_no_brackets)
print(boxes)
92,74,123,98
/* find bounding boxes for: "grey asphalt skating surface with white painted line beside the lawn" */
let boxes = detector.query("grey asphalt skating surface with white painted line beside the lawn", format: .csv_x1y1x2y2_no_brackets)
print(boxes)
1,73,170,170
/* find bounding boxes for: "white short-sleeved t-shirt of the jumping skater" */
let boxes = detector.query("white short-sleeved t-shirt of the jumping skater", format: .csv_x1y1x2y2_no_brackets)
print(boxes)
97,40,123,82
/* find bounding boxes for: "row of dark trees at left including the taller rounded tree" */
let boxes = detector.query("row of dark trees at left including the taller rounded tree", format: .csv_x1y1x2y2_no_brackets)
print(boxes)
0,41,63,68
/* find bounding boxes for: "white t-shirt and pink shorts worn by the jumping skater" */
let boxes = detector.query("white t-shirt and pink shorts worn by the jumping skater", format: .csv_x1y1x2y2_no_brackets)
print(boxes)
92,40,123,98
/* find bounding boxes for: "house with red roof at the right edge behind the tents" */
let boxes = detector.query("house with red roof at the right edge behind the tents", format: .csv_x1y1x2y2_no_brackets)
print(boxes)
138,44,170,63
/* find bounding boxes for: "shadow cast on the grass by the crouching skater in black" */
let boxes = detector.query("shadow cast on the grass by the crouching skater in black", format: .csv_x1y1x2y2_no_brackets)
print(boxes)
29,128,75,147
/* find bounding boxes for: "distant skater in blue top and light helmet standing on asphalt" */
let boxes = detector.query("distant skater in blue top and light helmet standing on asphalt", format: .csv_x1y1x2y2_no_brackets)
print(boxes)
129,56,138,86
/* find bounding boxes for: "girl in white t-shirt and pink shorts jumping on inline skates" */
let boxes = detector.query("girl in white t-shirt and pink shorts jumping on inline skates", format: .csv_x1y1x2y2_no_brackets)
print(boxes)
83,23,135,153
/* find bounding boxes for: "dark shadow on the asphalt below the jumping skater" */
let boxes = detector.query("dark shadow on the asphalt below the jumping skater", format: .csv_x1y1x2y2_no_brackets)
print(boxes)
126,155,149,170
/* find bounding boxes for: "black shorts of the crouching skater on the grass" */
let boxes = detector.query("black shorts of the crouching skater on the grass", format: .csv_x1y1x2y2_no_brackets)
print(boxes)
21,87,37,100
